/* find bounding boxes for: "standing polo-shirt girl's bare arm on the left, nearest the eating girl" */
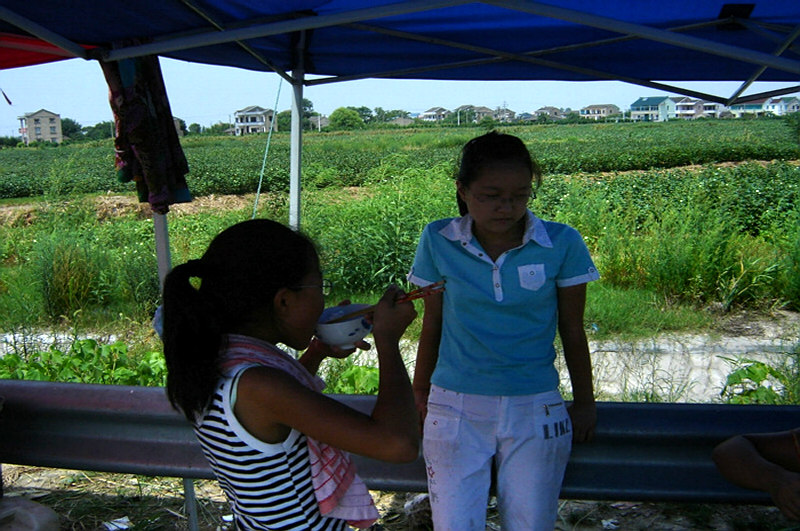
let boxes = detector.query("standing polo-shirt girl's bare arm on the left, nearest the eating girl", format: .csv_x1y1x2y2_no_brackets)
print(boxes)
413,293,444,422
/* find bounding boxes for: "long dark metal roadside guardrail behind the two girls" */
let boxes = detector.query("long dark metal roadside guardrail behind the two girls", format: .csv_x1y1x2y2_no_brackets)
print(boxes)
0,380,800,529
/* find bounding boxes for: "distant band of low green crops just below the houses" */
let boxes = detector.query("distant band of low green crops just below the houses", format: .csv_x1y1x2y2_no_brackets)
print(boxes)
0,119,800,199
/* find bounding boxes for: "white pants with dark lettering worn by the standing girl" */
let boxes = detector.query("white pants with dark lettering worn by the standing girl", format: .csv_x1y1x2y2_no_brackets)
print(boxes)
423,386,572,531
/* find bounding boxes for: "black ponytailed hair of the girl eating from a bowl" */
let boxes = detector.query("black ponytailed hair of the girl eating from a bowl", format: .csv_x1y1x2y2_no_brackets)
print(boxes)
163,219,317,421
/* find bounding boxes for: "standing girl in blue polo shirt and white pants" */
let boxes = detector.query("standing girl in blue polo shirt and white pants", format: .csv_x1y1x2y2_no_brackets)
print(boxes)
408,132,599,531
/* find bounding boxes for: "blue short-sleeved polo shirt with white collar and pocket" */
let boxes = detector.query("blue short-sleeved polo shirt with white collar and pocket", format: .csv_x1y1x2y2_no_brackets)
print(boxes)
408,211,600,396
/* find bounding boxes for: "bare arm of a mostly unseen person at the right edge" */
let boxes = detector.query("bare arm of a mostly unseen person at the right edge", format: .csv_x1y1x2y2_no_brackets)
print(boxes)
711,430,800,520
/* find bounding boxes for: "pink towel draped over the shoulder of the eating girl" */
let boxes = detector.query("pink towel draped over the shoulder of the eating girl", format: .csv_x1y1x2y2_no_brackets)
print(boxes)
220,334,379,528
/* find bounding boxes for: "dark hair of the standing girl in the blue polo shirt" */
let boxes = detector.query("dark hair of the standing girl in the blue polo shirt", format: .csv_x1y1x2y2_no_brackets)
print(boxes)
455,131,542,216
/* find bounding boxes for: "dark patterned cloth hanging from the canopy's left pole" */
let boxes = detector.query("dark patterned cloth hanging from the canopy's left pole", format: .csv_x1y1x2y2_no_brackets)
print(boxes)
100,55,192,214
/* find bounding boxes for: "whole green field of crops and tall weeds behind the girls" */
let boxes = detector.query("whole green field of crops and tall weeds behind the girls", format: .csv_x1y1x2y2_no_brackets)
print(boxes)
0,119,800,400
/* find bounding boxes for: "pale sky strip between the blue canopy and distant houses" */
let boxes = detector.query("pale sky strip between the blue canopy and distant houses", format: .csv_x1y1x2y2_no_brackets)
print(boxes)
0,58,791,136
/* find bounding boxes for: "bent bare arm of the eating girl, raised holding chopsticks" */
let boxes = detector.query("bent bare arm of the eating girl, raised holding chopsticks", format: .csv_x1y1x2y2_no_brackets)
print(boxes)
235,288,419,462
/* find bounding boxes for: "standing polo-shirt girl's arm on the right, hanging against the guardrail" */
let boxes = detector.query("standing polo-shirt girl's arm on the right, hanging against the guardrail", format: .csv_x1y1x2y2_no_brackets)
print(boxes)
558,284,597,442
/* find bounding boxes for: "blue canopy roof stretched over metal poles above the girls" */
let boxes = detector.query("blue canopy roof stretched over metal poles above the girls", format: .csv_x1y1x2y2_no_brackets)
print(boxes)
0,0,800,103
